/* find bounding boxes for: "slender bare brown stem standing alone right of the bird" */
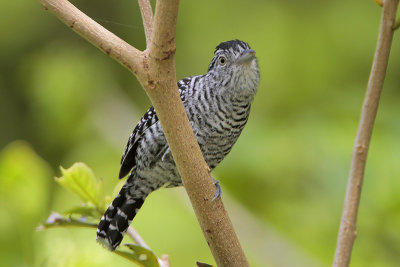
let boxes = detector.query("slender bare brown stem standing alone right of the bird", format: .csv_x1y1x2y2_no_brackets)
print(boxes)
333,0,399,267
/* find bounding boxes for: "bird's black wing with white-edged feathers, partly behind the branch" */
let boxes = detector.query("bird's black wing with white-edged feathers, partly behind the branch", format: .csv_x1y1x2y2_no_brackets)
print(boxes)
119,77,191,178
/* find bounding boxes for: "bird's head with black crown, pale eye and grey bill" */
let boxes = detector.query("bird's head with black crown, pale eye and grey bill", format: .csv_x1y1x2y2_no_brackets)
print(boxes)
208,40,260,96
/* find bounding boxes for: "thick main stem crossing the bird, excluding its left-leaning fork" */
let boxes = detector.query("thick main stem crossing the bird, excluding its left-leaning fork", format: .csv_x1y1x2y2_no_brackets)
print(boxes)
143,0,248,266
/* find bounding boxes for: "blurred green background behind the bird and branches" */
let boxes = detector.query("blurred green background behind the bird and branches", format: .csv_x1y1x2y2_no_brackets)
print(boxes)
0,0,400,266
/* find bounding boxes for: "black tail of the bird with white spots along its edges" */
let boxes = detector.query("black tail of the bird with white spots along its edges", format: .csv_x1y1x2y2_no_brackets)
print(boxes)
97,185,147,250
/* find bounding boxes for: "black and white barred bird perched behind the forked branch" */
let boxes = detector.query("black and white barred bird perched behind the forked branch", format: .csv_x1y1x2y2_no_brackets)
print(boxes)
97,40,260,250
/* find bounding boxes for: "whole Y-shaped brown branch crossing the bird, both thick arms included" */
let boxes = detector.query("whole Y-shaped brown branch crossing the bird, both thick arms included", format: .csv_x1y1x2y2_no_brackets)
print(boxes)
39,0,249,267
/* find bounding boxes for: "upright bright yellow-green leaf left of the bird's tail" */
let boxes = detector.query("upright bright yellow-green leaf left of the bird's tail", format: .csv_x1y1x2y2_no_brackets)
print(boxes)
56,162,104,213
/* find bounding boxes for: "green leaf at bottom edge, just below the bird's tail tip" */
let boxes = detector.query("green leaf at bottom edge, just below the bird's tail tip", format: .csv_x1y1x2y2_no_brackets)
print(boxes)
115,244,160,267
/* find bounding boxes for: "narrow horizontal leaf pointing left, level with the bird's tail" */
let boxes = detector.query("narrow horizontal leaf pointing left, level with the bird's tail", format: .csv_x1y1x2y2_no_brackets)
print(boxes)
36,212,97,231
